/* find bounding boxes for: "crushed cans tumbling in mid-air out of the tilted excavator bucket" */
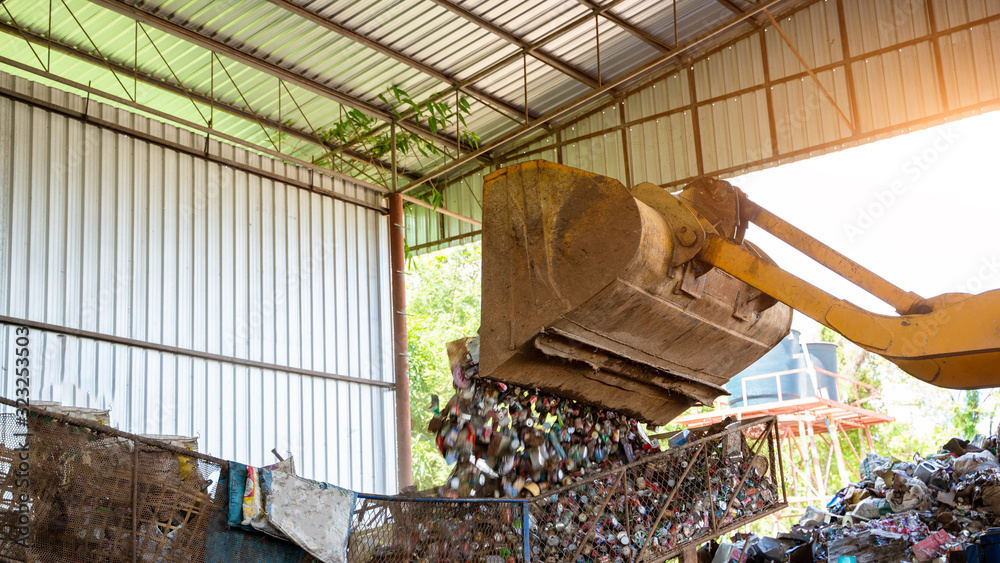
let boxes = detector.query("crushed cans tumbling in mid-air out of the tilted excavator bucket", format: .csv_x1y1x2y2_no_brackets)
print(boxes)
429,339,660,498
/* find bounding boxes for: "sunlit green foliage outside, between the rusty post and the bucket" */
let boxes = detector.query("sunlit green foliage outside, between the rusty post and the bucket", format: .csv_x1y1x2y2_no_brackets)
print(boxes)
406,242,482,490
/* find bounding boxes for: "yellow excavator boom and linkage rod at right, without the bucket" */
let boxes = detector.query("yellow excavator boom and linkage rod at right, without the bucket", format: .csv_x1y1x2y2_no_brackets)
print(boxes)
699,194,1000,389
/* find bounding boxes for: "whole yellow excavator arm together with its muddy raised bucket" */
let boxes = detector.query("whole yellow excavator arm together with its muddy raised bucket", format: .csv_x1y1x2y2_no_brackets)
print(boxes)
479,161,1000,424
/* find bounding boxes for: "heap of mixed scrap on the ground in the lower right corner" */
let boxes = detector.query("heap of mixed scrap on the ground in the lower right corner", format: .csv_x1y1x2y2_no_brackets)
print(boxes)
705,429,1000,563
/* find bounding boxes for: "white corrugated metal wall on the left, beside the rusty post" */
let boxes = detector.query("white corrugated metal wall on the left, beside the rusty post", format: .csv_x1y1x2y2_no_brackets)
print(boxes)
0,74,397,493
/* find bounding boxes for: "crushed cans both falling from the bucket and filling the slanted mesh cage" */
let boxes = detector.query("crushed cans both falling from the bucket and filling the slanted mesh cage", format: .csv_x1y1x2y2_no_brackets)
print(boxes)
418,340,785,561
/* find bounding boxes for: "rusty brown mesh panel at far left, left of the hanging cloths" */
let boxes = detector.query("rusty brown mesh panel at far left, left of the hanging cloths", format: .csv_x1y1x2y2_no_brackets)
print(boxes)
0,414,224,563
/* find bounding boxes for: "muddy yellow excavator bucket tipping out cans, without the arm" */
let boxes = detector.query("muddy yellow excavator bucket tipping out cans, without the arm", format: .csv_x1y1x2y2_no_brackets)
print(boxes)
479,161,792,425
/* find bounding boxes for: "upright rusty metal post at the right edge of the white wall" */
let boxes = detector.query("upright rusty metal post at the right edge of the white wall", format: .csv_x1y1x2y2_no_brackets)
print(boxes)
389,122,413,490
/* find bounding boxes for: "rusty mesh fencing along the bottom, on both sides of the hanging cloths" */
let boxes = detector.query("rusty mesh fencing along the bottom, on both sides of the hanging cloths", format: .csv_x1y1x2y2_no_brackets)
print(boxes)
0,406,784,563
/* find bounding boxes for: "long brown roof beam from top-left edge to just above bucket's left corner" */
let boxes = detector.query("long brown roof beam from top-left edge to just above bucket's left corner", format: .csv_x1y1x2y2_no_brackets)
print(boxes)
83,0,475,158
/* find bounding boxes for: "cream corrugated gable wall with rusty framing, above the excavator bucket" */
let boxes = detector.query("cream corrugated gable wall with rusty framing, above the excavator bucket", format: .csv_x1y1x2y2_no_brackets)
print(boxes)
408,0,1000,250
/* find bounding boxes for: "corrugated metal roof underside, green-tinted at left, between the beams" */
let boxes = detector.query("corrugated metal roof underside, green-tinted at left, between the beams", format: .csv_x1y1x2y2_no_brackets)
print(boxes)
0,0,760,192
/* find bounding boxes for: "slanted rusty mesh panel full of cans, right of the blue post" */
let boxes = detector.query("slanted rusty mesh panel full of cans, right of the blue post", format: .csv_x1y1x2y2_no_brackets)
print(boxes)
531,418,786,562
